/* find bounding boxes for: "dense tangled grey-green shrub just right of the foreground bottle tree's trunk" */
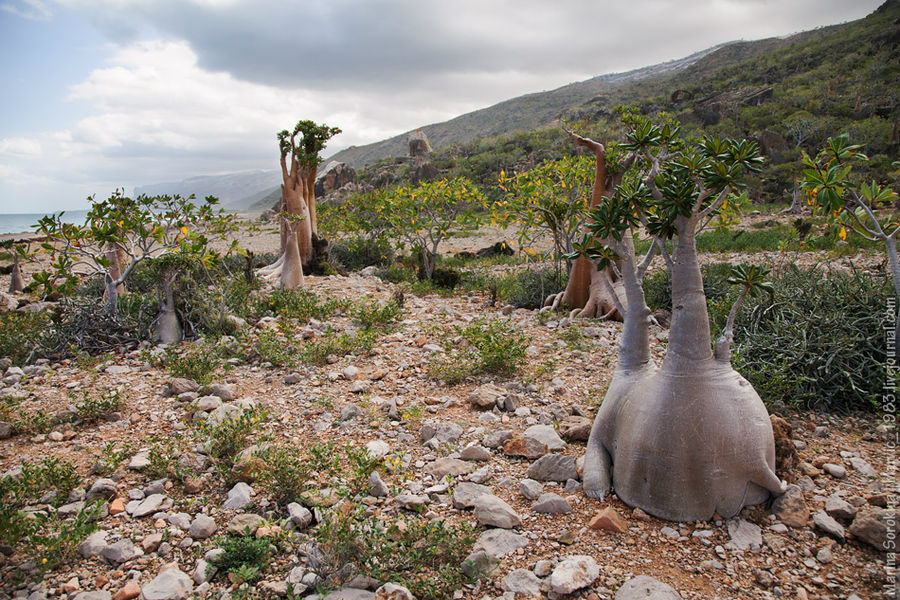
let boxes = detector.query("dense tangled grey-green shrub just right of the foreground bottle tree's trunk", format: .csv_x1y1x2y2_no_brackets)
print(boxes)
734,266,896,411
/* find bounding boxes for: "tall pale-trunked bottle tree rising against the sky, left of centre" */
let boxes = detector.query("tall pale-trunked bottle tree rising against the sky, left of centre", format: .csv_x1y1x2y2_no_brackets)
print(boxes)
260,120,341,288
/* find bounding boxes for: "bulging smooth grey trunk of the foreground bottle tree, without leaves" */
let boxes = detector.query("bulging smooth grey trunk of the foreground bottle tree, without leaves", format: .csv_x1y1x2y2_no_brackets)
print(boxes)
584,213,784,521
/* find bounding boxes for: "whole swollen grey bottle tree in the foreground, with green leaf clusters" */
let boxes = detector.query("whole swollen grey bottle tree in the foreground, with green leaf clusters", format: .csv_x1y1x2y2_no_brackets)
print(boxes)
577,111,784,521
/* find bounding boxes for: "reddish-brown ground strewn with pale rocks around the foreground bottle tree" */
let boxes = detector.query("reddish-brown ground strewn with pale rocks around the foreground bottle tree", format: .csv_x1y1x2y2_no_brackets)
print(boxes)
0,268,896,600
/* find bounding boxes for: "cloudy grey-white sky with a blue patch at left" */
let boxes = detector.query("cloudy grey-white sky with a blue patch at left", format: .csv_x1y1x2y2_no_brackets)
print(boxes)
0,0,881,213
